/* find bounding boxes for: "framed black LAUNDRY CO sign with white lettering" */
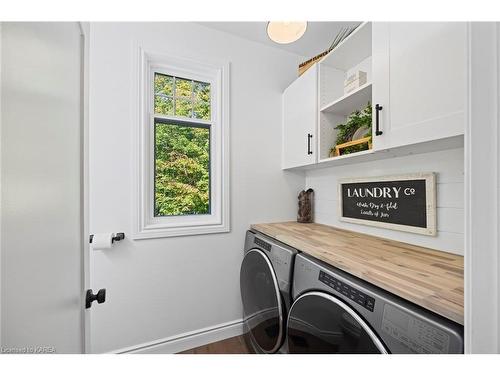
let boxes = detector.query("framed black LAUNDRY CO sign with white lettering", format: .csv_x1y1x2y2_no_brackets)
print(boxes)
339,173,436,236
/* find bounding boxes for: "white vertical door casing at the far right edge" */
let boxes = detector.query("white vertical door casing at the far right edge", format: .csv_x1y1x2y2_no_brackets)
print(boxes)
464,22,500,354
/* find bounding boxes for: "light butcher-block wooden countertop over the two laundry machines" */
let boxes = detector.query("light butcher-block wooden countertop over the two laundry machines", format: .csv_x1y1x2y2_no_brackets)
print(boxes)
252,222,464,324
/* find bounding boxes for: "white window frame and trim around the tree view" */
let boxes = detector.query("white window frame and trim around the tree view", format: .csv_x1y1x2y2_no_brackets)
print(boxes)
133,48,230,239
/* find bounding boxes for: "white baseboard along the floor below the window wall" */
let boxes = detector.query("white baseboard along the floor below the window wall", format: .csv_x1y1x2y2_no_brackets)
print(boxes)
111,320,243,354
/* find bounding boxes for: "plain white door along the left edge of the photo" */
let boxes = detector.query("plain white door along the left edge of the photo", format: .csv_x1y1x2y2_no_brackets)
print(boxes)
1,23,82,353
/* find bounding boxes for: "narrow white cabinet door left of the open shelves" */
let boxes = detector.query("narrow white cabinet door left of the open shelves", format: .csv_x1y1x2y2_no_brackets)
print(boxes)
283,64,318,169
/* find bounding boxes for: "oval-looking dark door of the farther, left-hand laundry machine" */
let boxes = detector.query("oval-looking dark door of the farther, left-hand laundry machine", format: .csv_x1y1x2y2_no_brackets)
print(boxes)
240,249,284,353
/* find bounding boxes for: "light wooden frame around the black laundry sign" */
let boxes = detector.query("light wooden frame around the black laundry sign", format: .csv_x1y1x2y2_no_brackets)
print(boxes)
338,172,437,236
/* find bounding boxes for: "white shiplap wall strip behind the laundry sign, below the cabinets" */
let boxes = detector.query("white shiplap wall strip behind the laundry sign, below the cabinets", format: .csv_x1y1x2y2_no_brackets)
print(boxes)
306,148,464,254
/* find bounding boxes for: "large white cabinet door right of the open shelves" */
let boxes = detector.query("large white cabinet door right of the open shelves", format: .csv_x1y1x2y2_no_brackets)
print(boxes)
372,22,467,149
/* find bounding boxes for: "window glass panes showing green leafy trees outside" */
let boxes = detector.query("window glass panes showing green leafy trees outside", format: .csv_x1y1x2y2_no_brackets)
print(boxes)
154,72,211,216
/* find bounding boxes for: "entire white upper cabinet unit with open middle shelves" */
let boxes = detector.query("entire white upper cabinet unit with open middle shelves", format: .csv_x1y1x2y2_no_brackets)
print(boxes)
283,22,469,169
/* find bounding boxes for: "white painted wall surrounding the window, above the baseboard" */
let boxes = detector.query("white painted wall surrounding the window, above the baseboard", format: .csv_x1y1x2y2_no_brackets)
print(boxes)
90,23,304,352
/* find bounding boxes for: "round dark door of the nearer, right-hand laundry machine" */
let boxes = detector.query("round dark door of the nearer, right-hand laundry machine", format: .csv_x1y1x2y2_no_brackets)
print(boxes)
288,292,387,354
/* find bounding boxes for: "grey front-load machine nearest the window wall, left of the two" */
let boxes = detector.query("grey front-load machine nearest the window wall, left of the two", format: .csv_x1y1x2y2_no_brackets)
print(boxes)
240,231,297,353
